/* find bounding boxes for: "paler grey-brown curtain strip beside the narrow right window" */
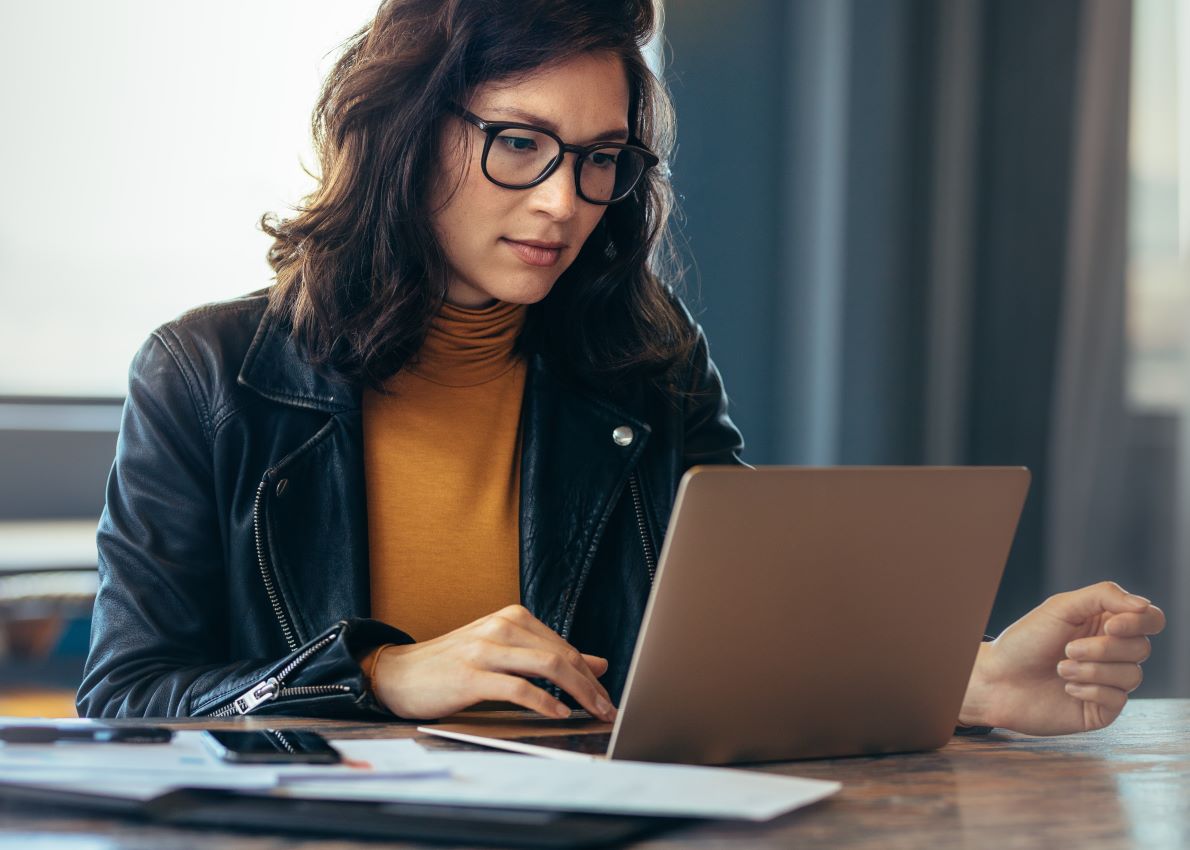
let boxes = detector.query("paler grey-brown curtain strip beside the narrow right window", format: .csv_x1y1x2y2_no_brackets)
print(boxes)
1046,0,1132,609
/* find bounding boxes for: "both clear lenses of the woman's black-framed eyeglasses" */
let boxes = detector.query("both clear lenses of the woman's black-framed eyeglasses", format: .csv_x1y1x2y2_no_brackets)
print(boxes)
487,127,645,201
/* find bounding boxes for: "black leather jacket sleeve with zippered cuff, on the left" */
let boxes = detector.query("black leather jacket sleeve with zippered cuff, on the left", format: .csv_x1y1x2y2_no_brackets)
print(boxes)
77,332,411,719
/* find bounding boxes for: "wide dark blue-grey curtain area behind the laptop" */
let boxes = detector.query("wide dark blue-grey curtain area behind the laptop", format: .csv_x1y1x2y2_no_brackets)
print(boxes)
666,0,1190,695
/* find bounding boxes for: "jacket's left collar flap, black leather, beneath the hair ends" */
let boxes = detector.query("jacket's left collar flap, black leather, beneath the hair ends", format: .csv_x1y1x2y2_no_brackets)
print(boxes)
237,312,359,413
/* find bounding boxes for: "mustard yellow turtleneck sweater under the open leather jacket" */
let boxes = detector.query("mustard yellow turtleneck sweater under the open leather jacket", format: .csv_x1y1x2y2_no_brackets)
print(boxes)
363,296,525,640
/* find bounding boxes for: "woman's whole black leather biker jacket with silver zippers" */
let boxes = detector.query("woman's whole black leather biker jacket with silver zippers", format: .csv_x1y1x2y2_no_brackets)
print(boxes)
77,293,743,717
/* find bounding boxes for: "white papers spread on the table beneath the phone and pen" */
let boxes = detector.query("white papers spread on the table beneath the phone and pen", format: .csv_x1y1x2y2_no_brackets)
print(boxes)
0,731,841,820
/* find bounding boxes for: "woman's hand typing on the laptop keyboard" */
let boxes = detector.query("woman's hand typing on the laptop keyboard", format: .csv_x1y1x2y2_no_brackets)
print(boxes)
372,605,615,721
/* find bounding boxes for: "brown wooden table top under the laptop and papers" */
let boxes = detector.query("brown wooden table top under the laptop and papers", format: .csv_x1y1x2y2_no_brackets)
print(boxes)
0,700,1190,850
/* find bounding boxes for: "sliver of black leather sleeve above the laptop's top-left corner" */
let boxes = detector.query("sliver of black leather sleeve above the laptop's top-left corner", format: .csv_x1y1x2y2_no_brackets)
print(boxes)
683,327,746,469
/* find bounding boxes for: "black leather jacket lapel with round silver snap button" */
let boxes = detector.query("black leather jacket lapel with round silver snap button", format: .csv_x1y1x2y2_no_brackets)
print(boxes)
520,355,650,637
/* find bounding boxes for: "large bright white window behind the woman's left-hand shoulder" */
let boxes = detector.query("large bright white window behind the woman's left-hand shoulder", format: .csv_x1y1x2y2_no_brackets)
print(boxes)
0,0,377,396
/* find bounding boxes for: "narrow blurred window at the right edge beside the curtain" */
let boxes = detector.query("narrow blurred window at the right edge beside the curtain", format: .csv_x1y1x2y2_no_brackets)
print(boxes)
1128,0,1190,412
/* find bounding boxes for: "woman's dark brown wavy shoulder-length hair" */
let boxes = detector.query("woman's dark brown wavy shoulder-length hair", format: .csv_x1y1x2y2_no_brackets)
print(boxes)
261,0,695,392
